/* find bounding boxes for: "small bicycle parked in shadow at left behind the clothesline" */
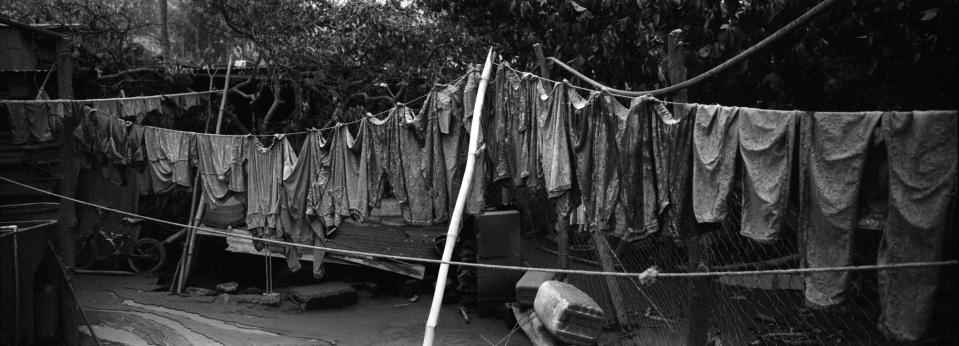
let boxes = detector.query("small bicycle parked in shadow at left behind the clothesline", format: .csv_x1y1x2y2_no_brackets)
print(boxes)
77,217,166,273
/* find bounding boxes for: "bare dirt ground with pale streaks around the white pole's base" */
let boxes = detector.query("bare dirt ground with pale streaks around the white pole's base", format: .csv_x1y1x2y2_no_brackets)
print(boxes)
74,275,530,345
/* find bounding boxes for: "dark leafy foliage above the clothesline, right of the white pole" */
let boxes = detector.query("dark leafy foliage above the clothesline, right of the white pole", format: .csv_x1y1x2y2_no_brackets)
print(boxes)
419,0,959,110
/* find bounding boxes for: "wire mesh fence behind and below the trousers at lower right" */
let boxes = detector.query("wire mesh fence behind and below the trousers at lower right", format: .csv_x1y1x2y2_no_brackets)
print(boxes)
487,174,959,345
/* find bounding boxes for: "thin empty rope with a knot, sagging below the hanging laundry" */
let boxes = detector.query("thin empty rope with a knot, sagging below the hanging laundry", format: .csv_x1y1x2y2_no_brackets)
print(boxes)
0,176,959,285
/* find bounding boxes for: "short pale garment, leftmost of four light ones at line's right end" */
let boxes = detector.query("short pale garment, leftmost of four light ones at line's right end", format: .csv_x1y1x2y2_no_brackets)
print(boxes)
692,105,739,222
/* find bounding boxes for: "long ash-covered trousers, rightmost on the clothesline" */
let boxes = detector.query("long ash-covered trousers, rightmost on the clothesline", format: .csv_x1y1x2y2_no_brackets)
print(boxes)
877,111,959,341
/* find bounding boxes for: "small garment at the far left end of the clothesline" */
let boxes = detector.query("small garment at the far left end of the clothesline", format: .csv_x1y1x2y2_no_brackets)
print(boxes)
4,101,53,144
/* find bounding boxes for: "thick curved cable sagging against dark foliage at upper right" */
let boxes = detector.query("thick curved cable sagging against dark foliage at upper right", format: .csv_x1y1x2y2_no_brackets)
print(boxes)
546,0,835,97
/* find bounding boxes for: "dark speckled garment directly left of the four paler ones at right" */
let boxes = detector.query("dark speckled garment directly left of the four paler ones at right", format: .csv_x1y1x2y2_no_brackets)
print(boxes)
652,103,697,237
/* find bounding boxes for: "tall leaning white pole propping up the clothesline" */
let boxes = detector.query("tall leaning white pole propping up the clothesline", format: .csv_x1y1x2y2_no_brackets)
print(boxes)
423,47,493,346
